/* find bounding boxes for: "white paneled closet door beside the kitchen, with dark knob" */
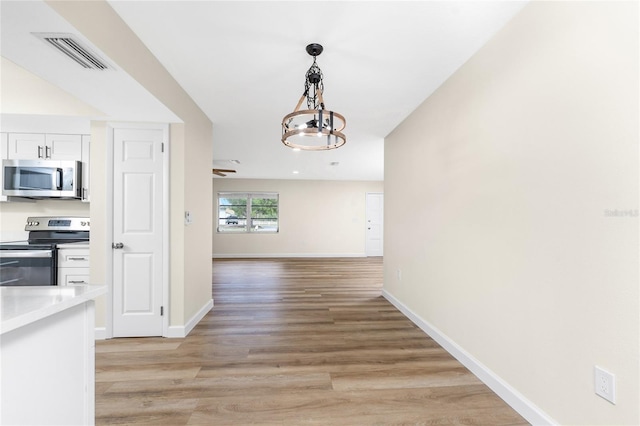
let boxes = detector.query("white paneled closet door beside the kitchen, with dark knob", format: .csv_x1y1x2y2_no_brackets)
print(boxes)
113,128,164,337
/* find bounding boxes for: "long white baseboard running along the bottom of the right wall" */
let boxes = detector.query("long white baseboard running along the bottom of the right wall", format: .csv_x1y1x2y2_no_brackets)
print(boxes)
382,290,558,425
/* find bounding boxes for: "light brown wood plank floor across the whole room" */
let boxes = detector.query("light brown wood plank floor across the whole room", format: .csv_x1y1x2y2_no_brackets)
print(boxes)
96,258,527,425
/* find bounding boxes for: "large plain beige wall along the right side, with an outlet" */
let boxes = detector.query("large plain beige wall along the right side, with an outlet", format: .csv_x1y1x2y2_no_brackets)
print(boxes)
384,2,640,425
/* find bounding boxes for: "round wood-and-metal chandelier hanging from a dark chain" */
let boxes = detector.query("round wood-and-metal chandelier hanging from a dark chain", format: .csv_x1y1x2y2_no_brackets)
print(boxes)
282,43,347,151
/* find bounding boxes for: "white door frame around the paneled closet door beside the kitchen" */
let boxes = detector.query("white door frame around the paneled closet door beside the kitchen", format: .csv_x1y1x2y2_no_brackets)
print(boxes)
104,122,171,339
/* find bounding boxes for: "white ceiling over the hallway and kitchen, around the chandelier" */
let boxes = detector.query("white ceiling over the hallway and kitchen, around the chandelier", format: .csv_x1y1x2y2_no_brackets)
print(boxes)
2,1,526,180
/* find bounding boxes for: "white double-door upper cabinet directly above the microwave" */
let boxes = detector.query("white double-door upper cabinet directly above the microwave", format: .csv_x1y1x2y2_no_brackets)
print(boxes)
8,133,82,161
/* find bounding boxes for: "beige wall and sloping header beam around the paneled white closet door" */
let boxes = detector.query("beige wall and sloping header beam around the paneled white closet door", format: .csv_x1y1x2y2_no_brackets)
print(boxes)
47,1,213,327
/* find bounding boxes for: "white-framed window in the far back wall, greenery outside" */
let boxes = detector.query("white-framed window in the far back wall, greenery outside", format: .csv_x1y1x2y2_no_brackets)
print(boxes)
218,192,278,233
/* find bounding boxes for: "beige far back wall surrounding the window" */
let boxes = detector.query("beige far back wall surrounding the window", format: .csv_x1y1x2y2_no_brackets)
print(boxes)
212,178,383,257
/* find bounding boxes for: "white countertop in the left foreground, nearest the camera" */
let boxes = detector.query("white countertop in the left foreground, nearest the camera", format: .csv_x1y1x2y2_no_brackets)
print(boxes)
0,285,107,335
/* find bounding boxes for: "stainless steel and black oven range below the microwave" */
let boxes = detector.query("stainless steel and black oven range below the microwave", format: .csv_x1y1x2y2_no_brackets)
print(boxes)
0,216,90,286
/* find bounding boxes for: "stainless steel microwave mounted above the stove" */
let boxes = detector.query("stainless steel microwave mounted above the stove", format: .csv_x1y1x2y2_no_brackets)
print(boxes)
2,160,82,198
